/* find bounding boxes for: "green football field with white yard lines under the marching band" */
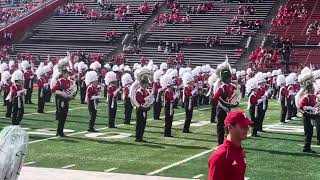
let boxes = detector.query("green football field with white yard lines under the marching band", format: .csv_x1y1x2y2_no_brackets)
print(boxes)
0,94,320,180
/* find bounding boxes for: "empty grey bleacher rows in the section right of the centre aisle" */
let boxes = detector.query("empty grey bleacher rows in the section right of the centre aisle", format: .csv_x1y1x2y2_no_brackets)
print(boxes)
146,0,273,45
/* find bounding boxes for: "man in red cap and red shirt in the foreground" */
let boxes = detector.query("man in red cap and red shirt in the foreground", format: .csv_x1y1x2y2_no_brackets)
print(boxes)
208,110,253,180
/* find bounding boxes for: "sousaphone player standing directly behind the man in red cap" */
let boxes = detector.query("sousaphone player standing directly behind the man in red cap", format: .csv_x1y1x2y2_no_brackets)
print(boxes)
213,56,239,145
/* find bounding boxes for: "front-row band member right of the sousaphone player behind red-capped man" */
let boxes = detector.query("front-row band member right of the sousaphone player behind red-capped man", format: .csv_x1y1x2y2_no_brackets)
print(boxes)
246,78,264,137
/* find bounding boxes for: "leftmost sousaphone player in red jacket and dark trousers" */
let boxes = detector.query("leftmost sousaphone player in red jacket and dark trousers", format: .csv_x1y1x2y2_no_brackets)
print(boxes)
51,59,73,137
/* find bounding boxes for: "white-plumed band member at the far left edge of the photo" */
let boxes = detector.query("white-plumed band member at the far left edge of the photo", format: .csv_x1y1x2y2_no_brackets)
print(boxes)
1,71,12,118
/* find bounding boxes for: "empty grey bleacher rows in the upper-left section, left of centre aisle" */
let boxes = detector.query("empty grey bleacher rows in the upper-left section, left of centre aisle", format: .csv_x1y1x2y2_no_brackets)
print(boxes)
30,0,157,42
